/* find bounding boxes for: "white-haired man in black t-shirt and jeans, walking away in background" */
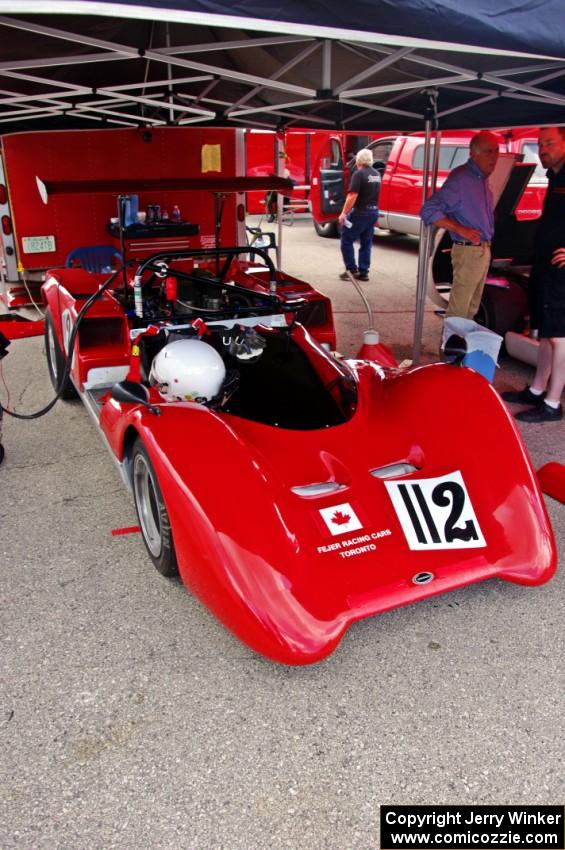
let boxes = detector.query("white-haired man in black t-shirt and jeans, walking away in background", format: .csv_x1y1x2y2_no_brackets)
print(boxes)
338,148,381,280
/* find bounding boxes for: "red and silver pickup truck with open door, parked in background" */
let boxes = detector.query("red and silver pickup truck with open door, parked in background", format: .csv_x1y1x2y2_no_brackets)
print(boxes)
310,130,547,237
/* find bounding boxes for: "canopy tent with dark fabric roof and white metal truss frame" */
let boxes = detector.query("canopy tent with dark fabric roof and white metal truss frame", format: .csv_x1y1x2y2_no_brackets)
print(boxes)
0,0,565,361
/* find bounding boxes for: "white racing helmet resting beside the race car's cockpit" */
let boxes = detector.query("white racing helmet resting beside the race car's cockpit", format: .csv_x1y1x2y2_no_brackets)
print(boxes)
149,339,226,403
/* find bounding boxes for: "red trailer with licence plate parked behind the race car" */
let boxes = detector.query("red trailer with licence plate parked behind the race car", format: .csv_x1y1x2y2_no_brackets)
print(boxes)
0,127,246,306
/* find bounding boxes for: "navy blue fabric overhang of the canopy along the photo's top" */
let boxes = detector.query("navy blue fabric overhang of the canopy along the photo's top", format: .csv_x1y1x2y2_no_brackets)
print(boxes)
16,0,565,59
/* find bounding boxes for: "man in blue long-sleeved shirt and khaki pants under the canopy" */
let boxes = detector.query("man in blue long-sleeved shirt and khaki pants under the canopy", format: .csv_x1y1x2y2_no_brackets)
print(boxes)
420,132,498,319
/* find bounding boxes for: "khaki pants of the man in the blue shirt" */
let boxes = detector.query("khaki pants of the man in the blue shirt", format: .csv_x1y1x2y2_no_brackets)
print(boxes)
445,243,490,319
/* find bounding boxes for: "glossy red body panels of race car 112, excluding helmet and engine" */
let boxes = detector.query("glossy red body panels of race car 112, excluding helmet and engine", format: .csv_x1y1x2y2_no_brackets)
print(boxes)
43,258,556,664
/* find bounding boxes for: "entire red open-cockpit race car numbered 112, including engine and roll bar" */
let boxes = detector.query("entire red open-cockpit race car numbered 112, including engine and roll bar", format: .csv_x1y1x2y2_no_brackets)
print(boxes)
43,242,556,664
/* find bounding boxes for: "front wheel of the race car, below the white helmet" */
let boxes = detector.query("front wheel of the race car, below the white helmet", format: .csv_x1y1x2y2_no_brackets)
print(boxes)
132,438,178,578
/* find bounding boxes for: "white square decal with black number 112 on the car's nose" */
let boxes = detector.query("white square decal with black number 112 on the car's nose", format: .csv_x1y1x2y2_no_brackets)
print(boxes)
384,472,487,549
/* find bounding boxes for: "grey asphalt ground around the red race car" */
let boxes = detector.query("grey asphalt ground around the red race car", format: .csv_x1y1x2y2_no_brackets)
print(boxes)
0,220,565,850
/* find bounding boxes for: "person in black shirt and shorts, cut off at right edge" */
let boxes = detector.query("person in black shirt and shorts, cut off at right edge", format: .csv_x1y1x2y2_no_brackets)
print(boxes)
502,127,565,422
